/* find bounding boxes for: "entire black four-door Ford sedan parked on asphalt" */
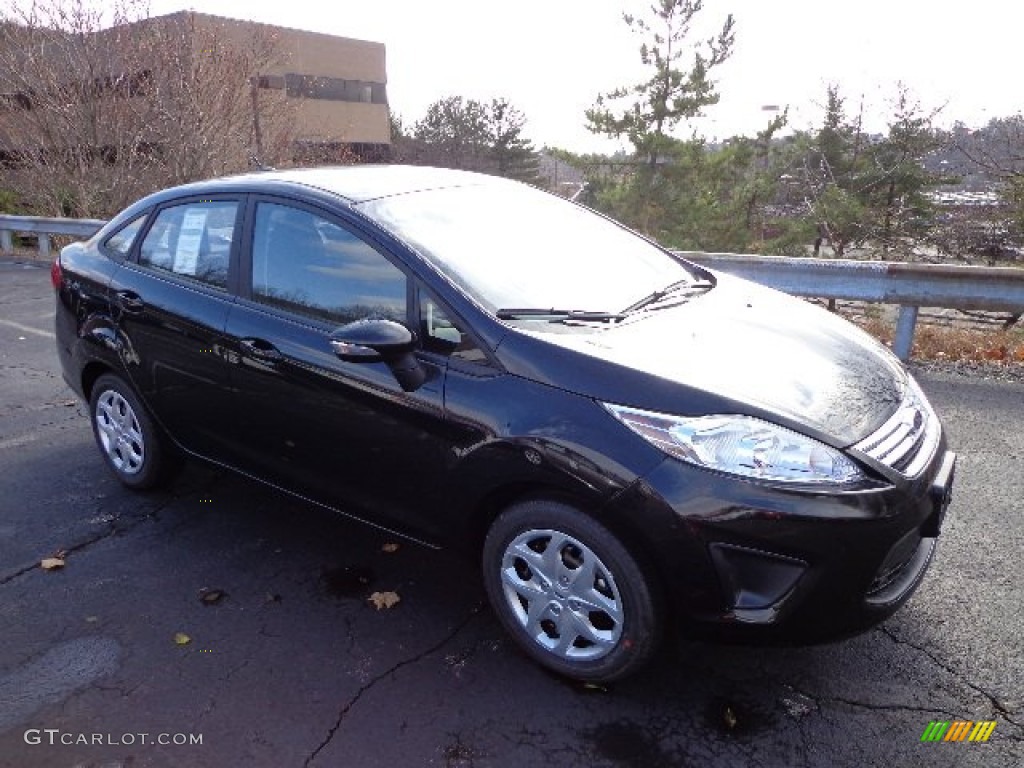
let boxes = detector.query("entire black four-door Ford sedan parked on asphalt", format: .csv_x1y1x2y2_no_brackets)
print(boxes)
52,166,954,681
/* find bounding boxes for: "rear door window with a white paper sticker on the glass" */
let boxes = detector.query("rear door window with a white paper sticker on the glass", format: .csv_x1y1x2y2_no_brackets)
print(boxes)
138,201,239,288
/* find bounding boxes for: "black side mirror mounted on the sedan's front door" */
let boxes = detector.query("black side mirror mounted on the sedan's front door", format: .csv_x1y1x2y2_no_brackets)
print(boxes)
330,318,427,392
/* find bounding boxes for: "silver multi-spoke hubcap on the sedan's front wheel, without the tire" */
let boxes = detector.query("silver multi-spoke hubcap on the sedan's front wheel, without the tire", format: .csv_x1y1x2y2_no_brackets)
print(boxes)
502,530,623,662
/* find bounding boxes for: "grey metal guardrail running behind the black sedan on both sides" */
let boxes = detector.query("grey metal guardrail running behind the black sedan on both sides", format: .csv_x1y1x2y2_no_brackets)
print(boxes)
0,215,1024,360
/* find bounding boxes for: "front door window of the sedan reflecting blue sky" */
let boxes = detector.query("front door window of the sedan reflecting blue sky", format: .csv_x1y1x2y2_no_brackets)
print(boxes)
252,203,407,326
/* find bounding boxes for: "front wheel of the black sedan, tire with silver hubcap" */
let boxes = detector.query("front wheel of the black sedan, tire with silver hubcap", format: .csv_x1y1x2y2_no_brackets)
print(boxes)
483,501,663,683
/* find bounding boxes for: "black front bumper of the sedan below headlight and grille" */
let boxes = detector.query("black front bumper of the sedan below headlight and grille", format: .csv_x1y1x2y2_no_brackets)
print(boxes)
602,430,956,643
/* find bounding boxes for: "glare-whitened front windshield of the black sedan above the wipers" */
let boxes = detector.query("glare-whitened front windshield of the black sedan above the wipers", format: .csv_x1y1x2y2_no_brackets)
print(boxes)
360,180,694,312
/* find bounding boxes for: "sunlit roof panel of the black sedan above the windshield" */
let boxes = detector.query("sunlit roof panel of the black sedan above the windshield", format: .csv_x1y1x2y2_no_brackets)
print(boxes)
206,165,508,203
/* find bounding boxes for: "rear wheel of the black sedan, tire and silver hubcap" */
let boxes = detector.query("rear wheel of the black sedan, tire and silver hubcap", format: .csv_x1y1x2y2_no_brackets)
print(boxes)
89,374,178,490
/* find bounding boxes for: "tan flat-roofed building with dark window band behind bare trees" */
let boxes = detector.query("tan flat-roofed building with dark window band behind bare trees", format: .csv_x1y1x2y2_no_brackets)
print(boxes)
0,11,391,162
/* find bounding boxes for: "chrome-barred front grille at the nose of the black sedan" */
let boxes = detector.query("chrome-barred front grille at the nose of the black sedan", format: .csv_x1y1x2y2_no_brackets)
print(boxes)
854,379,939,477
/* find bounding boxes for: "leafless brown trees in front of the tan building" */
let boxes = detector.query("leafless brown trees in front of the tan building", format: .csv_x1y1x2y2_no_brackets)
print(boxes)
0,0,293,216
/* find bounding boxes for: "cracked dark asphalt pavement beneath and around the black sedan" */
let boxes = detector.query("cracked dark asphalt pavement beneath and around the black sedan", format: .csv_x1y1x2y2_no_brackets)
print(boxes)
0,259,1024,768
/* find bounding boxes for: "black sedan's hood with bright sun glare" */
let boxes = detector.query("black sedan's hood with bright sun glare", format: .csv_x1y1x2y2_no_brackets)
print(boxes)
503,273,906,445
